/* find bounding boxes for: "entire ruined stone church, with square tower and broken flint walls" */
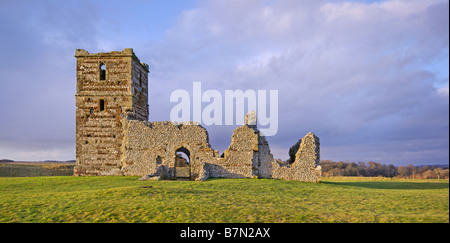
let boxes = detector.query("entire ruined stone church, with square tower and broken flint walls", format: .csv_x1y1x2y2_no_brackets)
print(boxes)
74,48,321,182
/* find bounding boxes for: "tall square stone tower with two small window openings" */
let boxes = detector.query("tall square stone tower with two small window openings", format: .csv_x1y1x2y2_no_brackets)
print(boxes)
74,48,149,175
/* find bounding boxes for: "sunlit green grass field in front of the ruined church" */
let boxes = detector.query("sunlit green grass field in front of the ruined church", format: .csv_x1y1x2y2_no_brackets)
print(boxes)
0,177,449,223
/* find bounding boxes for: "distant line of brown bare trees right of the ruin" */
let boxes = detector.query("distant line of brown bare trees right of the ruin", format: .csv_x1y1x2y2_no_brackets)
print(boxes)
320,160,449,179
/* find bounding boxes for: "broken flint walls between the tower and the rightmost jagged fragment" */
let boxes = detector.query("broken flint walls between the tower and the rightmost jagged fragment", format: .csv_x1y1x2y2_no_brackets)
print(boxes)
121,116,273,180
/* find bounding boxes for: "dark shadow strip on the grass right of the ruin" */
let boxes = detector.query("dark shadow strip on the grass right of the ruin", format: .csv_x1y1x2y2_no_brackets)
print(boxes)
322,181,449,190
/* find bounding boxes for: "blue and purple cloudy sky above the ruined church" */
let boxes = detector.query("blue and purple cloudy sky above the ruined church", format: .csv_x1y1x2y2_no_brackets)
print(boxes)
0,0,449,165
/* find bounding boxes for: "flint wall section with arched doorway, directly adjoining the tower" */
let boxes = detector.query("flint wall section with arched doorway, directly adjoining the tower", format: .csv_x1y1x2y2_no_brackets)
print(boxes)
122,117,214,180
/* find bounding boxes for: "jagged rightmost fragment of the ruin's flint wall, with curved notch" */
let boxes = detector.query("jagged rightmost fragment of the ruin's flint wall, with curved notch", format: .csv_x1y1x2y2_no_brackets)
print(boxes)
272,133,322,182
